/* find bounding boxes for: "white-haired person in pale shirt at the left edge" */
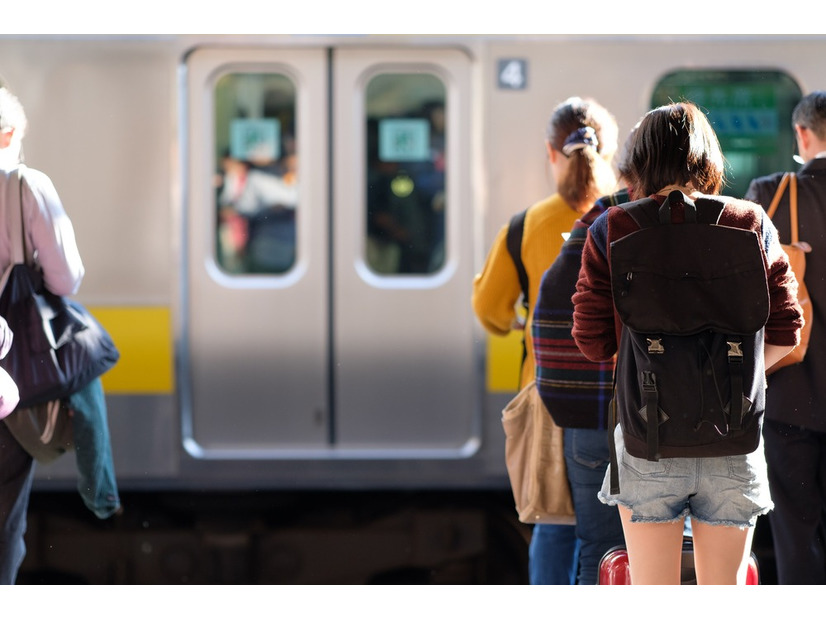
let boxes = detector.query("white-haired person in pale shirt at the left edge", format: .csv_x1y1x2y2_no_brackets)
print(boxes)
0,88,96,585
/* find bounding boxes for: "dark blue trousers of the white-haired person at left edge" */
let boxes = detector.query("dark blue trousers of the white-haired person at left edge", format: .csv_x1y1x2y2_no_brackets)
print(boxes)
0,422,34,585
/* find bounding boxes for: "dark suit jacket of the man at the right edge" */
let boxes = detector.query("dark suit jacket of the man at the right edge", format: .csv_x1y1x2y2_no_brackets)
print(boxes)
746,159,826,432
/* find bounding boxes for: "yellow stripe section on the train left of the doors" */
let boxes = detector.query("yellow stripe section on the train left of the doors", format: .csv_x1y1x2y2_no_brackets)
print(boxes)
89,306,174,394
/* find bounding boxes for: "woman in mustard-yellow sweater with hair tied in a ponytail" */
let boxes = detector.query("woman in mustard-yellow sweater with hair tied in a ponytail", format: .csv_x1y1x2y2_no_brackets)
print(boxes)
472,97,618,585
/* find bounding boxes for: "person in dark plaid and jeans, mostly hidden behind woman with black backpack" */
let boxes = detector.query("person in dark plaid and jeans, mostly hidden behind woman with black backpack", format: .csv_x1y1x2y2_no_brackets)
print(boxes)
531,127,636,585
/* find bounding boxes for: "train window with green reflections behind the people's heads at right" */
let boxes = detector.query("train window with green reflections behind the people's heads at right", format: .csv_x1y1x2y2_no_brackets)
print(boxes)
651,69,802,196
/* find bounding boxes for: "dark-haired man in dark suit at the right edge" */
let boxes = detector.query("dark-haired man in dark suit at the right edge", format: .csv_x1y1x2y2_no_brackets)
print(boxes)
746,91,826,584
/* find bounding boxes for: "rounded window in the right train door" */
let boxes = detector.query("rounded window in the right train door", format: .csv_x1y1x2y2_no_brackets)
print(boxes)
365,73,446,275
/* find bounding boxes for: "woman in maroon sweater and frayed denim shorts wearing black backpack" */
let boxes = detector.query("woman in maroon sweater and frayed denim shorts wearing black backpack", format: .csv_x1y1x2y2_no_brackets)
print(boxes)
573,102,802,585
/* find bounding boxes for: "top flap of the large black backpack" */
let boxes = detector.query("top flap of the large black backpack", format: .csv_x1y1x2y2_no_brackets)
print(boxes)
610,198,770,335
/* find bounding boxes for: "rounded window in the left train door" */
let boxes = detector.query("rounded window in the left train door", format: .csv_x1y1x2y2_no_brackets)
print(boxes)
214,73,298,274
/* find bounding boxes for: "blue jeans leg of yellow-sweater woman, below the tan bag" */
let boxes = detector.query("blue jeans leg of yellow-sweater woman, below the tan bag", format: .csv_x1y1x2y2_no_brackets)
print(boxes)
528,523,579,586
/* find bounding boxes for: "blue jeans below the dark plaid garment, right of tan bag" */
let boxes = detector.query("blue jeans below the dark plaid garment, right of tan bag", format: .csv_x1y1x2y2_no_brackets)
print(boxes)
565,428,625,585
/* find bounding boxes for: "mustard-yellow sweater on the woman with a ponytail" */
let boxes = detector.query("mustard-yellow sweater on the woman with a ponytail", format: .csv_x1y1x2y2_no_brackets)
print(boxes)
471,194,581,387
